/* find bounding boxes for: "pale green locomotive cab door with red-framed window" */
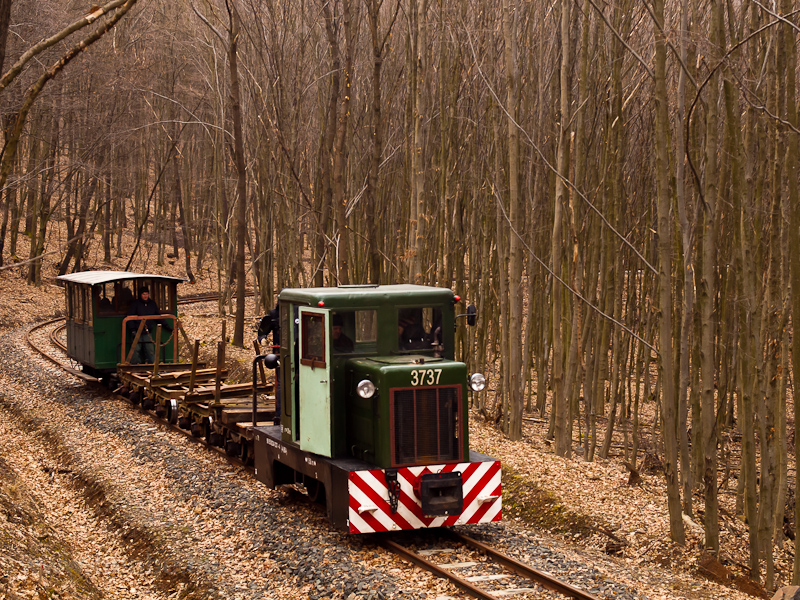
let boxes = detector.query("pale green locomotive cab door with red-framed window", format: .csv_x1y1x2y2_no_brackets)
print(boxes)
298,308,331,456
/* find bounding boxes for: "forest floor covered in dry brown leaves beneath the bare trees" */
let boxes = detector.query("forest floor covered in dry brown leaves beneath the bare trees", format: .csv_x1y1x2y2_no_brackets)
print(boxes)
0,227,794,600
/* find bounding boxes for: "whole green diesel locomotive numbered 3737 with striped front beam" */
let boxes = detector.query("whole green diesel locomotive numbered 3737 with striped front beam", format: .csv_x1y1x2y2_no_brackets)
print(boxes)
253,285,502,533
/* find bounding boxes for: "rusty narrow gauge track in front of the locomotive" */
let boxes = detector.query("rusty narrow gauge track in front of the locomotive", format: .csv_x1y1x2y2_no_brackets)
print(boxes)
379,529,598,600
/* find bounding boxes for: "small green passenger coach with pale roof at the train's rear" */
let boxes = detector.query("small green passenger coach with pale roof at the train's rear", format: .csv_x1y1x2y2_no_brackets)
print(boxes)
58,271,183,378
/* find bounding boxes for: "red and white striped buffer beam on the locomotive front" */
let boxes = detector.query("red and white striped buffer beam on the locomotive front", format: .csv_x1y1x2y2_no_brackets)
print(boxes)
347,460,503,533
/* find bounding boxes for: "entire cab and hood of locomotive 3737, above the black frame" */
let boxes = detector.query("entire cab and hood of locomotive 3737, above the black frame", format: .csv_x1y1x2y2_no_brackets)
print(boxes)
279,285,468,467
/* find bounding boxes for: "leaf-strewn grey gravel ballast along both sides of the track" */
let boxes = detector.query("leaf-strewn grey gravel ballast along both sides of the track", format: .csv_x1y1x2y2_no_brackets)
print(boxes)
0,330,712,600
